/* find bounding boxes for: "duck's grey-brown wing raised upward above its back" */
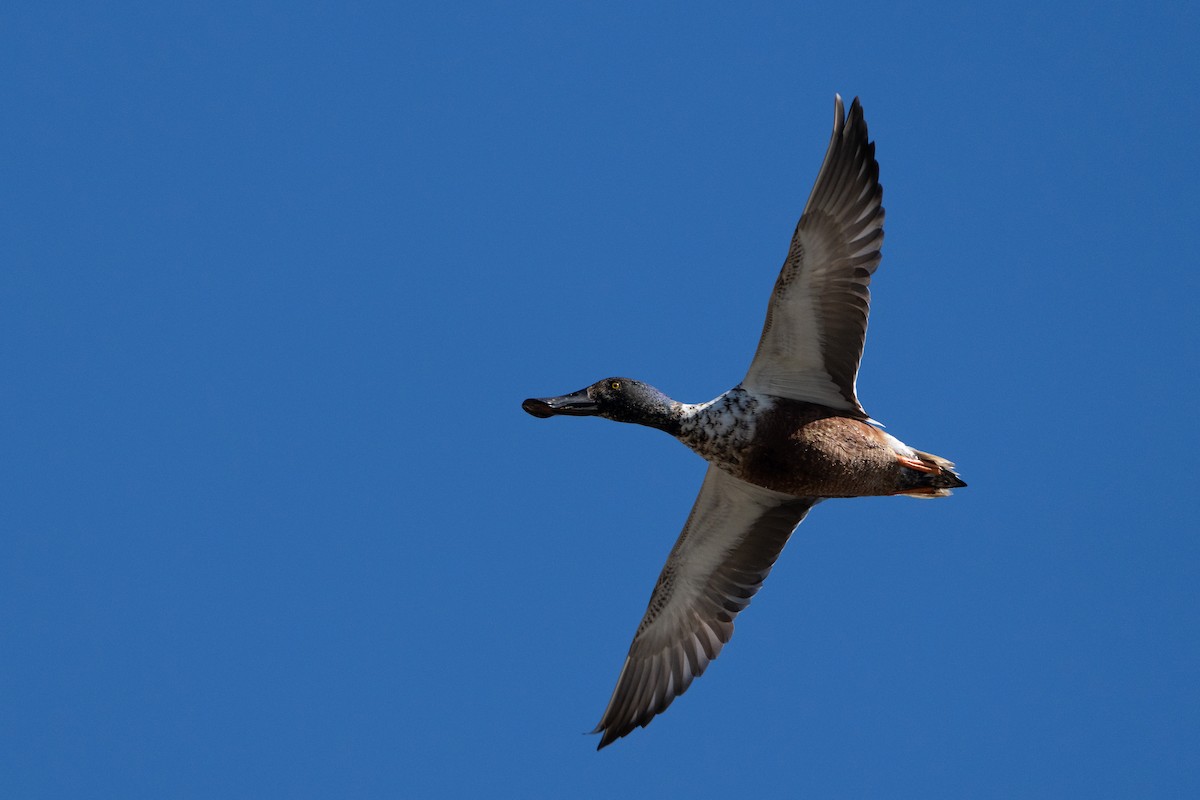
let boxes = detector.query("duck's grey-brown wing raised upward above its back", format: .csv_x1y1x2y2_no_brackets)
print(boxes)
743,97,883,419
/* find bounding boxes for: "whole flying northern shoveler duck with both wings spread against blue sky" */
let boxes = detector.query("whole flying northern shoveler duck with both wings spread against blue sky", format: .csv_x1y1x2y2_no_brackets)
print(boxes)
522,96,966,748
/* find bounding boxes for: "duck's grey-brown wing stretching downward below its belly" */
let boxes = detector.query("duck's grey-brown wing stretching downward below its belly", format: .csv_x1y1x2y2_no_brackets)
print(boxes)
592,467,816,750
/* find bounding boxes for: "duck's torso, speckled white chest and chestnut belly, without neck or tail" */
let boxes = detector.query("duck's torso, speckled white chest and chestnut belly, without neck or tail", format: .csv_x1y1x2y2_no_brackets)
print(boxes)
679,392,899,498
